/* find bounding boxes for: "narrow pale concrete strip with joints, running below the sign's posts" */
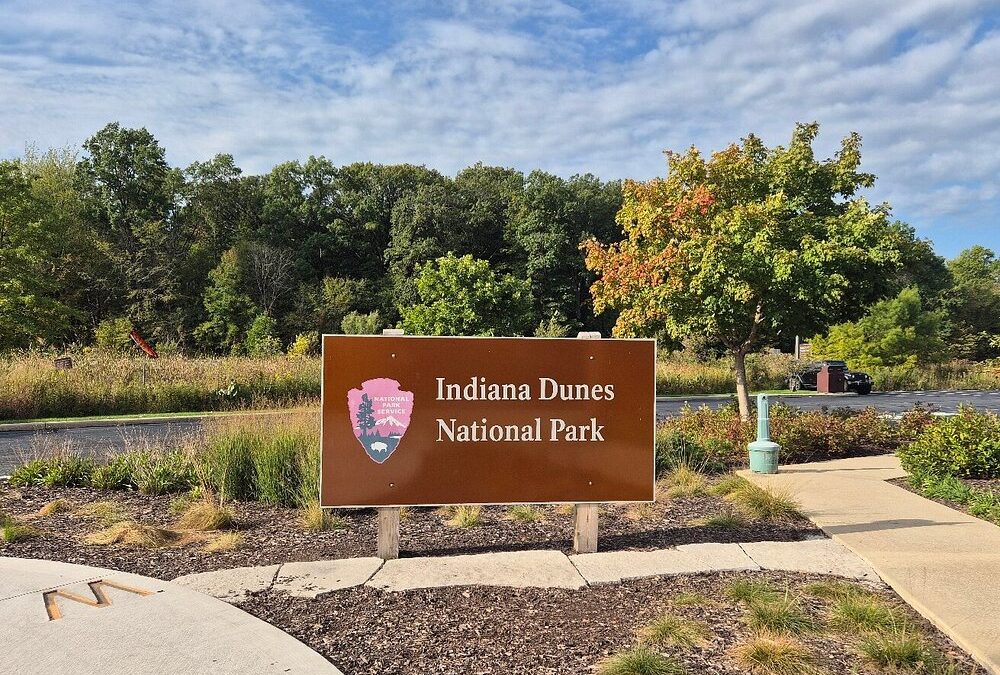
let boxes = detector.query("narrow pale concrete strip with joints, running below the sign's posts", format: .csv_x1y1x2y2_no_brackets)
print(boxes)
174,537,881,602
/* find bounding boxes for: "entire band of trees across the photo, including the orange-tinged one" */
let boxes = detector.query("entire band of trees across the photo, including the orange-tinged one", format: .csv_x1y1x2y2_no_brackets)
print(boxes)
0,123,1000,379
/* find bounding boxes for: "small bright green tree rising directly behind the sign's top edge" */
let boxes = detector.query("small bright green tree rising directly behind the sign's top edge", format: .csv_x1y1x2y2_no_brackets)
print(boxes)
399,253,533,335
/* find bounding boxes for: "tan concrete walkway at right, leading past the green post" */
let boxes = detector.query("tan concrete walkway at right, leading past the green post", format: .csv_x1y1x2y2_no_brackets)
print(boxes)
742,455,1000,675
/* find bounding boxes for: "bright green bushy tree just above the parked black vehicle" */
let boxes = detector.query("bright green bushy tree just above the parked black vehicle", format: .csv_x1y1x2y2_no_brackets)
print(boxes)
812,286,946,368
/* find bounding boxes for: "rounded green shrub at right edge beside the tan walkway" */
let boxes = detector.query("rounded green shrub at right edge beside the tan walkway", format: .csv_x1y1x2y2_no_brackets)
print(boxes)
899,406,1000,478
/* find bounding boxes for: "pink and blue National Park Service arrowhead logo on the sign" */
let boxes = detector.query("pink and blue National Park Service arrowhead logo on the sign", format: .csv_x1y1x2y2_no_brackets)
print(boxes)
347,377,413,464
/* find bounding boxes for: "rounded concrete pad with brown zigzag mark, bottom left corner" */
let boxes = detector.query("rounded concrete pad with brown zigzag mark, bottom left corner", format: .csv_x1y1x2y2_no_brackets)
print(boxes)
0,557,342,675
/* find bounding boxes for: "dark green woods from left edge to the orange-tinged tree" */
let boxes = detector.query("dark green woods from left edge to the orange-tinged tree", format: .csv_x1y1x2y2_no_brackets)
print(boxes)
0,123,621,354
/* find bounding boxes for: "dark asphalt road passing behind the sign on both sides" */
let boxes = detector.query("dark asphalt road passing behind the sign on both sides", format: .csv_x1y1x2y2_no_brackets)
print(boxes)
0,391,1000,476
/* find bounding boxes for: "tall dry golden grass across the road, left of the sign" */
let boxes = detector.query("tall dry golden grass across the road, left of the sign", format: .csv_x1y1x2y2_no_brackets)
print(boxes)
0,351,320,420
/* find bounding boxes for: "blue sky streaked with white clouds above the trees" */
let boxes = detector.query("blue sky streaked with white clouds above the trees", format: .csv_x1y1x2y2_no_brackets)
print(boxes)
0,0,1000,256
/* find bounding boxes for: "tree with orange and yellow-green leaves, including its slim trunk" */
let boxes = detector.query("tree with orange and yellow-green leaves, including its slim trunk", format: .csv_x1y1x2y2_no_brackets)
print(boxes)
584,124,907,417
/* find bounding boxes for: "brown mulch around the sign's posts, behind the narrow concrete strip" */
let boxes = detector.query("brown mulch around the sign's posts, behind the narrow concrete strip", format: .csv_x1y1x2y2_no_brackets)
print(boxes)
0,485,822,580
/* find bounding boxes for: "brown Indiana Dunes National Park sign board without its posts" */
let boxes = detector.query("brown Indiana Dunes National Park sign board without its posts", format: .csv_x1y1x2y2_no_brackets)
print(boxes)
320,335,656,507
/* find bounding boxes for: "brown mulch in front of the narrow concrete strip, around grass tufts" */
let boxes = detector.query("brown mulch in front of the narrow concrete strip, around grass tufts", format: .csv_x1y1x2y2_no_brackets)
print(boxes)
239,572,981,675
